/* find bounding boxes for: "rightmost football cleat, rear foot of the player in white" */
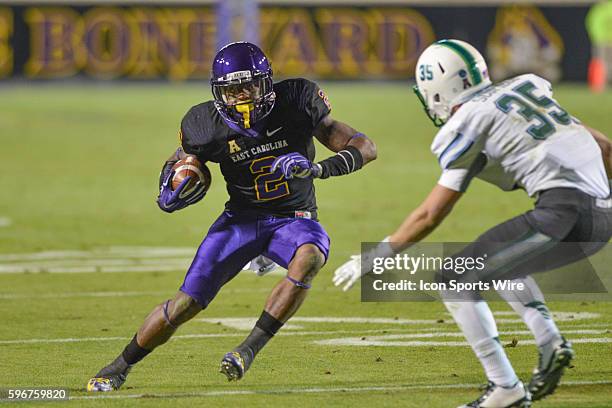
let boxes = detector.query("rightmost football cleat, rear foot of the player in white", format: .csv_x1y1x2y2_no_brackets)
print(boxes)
529,337,575,401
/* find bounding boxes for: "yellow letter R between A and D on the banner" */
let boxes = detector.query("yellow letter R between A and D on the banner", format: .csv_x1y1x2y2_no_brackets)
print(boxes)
315,8,381,77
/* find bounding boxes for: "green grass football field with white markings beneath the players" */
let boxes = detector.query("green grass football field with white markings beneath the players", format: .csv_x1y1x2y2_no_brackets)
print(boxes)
0,83,612,408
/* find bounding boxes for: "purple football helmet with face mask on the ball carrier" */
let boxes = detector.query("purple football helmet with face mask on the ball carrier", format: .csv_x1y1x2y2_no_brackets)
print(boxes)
210,41,276,129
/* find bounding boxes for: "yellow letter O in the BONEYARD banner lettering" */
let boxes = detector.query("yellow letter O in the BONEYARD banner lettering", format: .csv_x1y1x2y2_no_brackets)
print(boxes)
83,7,130,78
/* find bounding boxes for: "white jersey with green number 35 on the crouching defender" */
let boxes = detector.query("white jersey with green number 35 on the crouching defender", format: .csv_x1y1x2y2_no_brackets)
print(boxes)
431,74,610,198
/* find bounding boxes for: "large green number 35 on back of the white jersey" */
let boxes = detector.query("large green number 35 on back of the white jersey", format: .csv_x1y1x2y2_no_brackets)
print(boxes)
495,81,572,140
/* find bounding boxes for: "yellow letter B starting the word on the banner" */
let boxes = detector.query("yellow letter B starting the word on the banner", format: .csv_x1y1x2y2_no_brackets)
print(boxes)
25,7,87,77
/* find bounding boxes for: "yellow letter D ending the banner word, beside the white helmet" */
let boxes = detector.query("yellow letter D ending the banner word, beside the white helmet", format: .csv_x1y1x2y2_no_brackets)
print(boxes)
371,9,435,77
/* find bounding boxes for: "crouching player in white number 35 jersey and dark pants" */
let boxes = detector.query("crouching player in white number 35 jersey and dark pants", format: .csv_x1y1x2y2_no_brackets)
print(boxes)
334,40,612,408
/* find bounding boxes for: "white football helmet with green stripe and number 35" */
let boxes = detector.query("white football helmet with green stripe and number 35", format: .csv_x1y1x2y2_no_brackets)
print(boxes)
414,40,491,127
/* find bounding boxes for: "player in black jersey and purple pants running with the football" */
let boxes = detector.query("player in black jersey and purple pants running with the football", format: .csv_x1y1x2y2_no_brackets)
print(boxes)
87,42,376,391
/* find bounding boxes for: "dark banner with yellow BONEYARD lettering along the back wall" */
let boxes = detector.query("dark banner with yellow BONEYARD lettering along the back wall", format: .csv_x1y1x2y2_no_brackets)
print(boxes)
0,3,590,80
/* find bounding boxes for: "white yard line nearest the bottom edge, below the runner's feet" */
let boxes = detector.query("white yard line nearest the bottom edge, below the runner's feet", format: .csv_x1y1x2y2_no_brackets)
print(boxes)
70,380,612,400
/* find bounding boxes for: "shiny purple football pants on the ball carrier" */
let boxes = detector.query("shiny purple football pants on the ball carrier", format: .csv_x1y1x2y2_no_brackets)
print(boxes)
180,211,329,307
